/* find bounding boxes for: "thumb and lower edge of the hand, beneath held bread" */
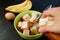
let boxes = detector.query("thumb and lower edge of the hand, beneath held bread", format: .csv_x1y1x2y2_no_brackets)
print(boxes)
38,22,60,33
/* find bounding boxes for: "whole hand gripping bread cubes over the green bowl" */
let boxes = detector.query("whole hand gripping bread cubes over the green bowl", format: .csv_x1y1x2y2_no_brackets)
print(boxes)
39,7,60,33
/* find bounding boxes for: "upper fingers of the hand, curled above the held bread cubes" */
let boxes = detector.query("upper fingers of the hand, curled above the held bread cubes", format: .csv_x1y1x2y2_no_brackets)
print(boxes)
42,7,60,17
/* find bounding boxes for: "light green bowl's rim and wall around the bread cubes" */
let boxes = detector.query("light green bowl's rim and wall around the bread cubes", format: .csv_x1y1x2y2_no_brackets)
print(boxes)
14,10,42,39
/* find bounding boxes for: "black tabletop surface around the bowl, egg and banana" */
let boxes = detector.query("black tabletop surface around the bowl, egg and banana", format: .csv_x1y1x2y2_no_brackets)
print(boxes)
0,0,60,40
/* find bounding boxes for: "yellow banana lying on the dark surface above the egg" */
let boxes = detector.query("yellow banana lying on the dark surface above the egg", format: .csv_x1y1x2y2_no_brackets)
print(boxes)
5,0,32,13
